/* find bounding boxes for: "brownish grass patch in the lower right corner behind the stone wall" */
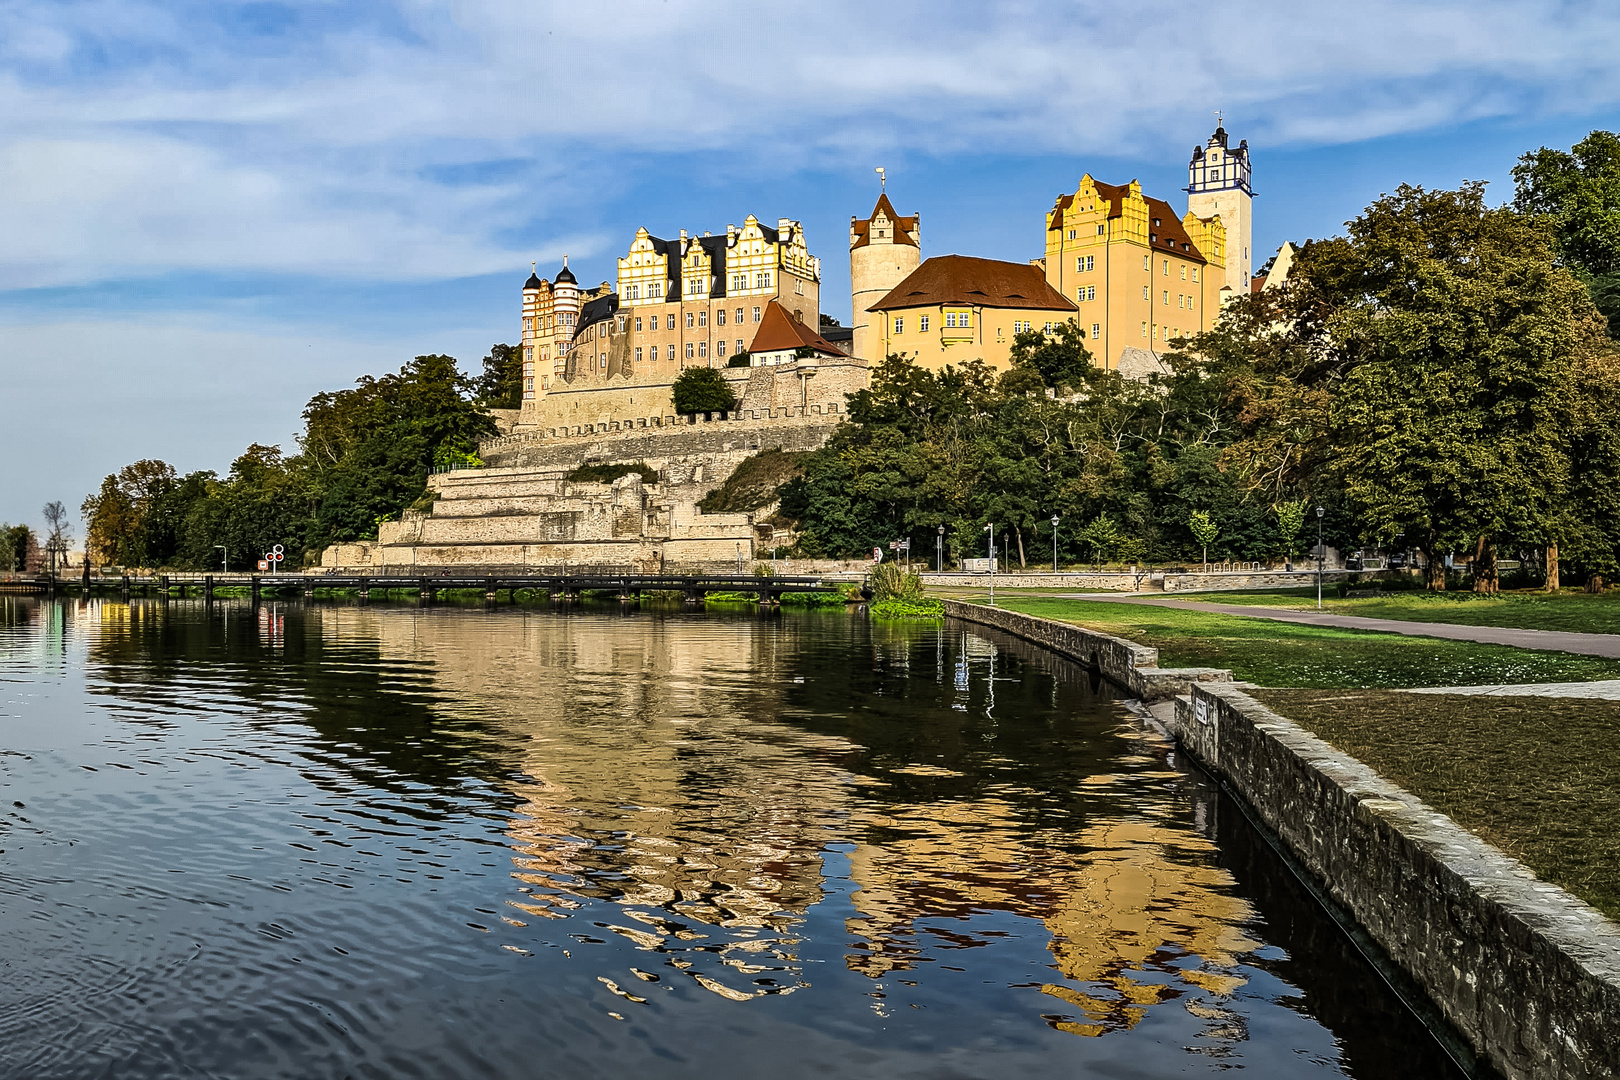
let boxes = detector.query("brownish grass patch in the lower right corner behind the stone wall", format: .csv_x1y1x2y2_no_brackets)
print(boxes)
1256,690,1620,920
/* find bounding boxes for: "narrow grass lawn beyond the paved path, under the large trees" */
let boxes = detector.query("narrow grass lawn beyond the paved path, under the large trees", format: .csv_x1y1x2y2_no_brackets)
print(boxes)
1184,588,1620,633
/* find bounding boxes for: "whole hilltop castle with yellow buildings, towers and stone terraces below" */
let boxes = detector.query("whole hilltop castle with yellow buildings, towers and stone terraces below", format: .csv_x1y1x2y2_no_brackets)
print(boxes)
322,126,1293,570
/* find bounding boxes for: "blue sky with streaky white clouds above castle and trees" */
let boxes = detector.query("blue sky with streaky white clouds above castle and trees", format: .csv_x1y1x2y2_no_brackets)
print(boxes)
0,0,1620,538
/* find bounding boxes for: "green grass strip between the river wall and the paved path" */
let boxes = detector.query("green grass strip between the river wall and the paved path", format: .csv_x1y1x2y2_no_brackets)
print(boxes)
977,594,1620,688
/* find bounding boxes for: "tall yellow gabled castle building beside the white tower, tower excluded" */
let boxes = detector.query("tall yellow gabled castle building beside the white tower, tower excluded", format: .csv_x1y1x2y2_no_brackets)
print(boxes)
1042,173,1226,368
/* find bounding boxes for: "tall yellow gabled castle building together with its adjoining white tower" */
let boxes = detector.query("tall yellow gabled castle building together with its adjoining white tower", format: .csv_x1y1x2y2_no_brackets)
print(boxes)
1038,126,1254,369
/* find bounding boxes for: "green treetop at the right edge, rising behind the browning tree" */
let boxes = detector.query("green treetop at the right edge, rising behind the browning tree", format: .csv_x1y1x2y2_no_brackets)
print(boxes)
1513,131,1620,338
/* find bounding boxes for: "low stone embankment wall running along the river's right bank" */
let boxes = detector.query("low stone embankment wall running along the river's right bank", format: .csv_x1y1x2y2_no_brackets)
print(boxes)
946,601,1620,1080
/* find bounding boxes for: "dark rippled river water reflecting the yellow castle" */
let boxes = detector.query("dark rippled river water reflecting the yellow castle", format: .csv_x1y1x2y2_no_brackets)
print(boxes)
0,597,1456,1080
